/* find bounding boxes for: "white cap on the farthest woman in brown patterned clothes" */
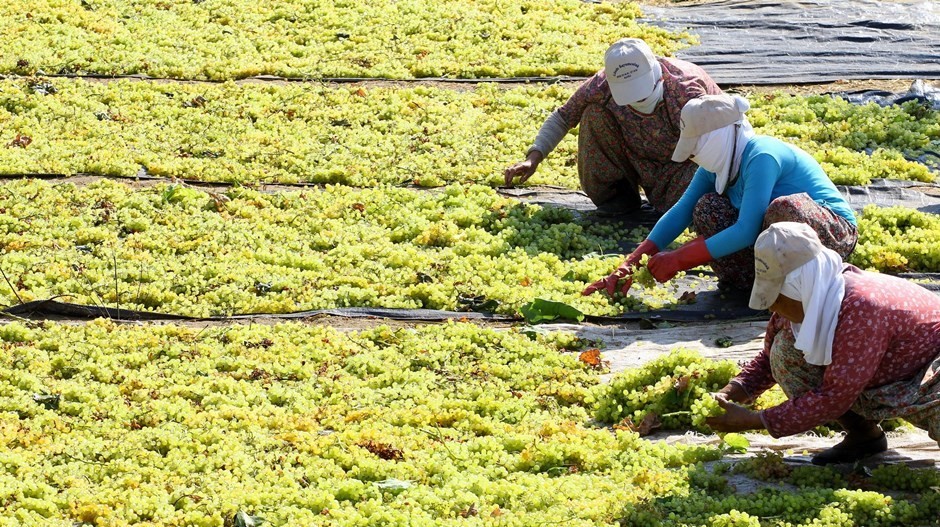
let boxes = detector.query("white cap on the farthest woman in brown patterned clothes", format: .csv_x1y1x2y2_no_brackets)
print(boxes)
604,38,662,106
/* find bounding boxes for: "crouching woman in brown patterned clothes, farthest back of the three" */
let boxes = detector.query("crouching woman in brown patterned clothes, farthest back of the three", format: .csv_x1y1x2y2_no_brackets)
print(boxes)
505,38,721,213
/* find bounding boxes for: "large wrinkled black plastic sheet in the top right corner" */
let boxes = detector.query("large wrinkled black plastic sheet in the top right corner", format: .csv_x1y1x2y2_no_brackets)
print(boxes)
643,0,940,85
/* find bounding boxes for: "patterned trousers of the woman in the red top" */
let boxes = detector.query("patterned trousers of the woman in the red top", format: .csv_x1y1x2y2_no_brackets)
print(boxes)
770,327,940,445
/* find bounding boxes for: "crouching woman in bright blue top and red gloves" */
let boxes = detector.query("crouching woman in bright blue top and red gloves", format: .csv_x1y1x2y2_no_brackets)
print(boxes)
583,94,858,296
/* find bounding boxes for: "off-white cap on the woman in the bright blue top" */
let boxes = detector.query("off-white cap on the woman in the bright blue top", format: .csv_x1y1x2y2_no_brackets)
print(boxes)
672,93,751,163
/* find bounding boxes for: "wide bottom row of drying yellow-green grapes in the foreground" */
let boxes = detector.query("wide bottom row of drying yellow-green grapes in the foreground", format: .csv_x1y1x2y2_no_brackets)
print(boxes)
0,320,940,527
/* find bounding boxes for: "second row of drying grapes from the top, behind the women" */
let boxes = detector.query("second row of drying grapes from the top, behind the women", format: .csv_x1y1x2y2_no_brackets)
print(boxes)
0,78,940,188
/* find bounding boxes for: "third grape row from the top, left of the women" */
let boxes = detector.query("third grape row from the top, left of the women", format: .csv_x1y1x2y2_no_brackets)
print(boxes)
0,180,696,317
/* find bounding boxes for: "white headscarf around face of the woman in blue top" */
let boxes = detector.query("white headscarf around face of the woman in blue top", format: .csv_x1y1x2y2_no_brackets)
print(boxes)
692,118,754,194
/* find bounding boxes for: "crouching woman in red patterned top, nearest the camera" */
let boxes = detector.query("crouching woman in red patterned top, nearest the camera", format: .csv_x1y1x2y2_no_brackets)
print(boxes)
707,222,940,465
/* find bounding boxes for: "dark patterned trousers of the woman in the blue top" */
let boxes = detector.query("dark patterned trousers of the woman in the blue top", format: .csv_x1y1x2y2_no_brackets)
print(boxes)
692,192,858,289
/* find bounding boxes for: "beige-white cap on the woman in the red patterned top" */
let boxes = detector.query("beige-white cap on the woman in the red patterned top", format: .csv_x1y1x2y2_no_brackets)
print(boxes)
748,221,823,309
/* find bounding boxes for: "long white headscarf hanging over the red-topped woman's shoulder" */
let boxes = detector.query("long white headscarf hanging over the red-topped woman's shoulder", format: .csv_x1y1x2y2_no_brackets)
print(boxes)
780,248,845,366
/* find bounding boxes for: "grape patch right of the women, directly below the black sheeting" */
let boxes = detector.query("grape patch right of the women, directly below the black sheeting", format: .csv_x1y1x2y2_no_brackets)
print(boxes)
748,93,940,185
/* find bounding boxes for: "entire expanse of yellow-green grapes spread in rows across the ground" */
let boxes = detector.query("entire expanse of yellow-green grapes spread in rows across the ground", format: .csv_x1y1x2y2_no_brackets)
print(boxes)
0,0,940,527
